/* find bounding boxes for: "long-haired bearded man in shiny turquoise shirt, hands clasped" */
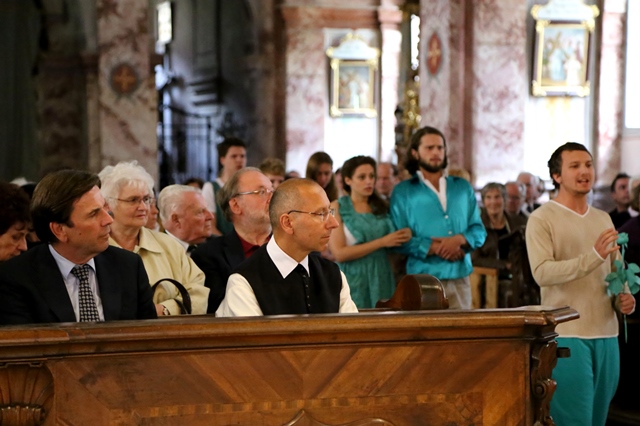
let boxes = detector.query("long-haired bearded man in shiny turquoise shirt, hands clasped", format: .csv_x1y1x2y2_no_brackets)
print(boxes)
391,126,487,309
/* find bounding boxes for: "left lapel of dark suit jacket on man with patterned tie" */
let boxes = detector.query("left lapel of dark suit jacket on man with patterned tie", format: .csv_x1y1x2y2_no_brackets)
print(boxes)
35,244,77,322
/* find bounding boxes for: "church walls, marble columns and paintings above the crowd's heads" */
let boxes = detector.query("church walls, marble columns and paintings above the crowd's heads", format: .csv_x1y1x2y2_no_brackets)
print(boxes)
0,0,640,210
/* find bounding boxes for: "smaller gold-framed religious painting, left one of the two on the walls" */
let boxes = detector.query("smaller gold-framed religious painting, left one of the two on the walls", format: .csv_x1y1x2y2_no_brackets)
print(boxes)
329,59,378,117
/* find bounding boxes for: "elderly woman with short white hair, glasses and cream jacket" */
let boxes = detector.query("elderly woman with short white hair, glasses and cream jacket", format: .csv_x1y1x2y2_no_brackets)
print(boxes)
99,161,209,316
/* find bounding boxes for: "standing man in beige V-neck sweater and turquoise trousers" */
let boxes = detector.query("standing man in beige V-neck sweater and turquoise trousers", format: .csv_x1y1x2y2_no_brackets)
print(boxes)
526,142,635,426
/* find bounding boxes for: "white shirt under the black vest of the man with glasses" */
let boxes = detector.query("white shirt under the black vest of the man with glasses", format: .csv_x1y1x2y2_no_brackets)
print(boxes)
216,237,358,317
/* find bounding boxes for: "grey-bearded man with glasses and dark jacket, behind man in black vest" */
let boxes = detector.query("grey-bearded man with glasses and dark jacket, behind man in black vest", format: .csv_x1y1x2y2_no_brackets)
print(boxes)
191,167,273,313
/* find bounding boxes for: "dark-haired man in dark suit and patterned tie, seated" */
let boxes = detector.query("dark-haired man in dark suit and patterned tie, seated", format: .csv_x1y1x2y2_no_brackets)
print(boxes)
0,170,157,324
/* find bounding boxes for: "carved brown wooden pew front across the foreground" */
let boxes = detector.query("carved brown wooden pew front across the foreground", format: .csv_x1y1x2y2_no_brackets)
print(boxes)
0,308,578,426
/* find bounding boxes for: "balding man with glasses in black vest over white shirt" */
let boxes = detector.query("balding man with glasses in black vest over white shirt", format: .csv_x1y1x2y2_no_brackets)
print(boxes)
216,179,358,317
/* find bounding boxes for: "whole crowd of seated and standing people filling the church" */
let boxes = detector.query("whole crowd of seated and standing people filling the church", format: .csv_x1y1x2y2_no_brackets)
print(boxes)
0,126,640,424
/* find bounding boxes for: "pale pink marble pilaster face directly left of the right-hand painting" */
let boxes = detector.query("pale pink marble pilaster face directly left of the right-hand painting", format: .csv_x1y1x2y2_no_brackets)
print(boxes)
467,0,529,187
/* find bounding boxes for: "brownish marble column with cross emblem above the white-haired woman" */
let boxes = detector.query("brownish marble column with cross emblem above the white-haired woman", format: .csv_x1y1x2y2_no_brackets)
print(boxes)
95,0,158,178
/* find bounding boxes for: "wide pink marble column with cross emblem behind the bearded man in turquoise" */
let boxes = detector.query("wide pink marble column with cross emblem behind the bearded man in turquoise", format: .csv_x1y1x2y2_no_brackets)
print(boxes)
420,0,528,186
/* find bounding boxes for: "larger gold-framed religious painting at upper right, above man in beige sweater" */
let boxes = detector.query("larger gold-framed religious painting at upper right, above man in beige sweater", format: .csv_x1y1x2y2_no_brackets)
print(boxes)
532,20,593,97
